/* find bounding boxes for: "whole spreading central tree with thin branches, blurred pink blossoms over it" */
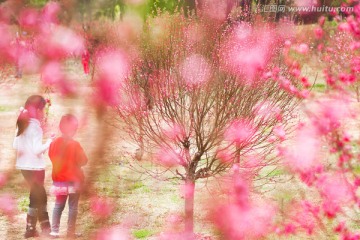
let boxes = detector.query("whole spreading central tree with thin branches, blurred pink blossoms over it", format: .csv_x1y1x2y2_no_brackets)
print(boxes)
117,15,307,234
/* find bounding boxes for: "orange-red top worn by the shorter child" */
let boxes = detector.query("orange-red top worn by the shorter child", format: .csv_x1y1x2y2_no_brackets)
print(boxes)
49,137,88,182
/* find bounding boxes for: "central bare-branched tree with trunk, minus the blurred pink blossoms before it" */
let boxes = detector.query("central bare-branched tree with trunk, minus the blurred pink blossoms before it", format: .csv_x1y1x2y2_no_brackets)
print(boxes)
117,17,297,234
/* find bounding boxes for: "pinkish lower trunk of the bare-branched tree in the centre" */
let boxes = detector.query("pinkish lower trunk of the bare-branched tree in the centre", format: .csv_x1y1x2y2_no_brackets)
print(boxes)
185,180,195,236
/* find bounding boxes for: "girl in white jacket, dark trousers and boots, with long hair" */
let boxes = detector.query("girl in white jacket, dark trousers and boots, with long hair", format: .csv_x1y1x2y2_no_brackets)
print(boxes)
13,95,52,238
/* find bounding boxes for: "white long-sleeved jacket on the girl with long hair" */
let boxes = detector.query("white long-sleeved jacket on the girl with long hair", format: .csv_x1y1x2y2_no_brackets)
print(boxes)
13,118,51,170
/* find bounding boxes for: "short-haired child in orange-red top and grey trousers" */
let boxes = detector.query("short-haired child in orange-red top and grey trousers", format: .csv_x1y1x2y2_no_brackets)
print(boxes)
49,114,88,237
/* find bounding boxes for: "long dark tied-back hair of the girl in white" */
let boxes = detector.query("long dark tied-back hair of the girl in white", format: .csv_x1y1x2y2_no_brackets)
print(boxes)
16,95,46,136
